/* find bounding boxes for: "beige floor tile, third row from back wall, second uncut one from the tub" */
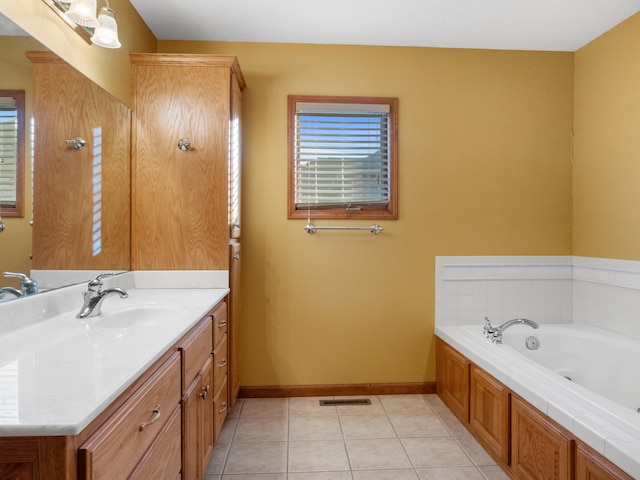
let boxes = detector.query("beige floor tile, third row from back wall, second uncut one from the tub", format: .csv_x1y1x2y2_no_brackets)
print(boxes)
346,438,412,470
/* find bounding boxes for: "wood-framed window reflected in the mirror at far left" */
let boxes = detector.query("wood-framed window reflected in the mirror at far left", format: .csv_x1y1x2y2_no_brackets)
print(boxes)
0,90,25,217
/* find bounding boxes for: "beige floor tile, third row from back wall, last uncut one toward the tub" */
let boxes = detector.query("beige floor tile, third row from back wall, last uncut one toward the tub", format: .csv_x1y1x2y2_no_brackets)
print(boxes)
402,437,473,468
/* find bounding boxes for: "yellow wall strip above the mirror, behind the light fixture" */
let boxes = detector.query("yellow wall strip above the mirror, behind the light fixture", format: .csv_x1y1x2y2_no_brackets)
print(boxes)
0,0,156,105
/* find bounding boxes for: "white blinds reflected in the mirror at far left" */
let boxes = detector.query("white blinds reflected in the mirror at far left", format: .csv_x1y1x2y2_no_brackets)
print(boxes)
0,97,18,205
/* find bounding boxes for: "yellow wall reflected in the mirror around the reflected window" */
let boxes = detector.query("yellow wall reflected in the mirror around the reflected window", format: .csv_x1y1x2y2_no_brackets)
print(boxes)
0,37,44,287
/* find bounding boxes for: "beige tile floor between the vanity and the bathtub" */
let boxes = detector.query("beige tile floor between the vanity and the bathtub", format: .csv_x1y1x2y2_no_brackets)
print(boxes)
205,395,508,480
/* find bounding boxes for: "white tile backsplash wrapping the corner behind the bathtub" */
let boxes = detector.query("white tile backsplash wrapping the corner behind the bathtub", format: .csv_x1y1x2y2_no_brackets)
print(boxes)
435,256,640,339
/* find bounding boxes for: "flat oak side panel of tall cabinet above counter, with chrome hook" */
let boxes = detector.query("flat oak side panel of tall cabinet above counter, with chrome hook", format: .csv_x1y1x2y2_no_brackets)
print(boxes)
132,56,231,270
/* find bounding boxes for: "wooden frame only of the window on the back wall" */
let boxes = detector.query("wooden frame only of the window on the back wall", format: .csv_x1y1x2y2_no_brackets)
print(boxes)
287,95,398,220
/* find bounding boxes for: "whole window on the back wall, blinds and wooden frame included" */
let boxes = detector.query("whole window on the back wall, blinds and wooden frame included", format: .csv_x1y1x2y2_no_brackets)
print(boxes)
288,95,398,219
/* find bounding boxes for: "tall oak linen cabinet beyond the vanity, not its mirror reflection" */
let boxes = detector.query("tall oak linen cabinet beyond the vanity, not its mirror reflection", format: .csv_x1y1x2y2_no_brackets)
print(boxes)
131,54,245,468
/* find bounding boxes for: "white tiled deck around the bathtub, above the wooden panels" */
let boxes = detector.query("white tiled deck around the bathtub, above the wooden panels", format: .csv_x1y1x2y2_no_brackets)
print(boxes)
436,324,640,478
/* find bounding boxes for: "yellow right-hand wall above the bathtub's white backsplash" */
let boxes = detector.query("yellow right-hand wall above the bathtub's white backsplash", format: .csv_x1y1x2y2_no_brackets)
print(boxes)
573,14,640,260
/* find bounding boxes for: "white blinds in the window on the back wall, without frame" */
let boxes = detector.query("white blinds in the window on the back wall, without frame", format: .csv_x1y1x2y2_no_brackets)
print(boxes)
294,102,390,210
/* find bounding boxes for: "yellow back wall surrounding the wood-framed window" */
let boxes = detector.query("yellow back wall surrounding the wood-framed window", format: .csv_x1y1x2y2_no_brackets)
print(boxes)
159,42,573,386
